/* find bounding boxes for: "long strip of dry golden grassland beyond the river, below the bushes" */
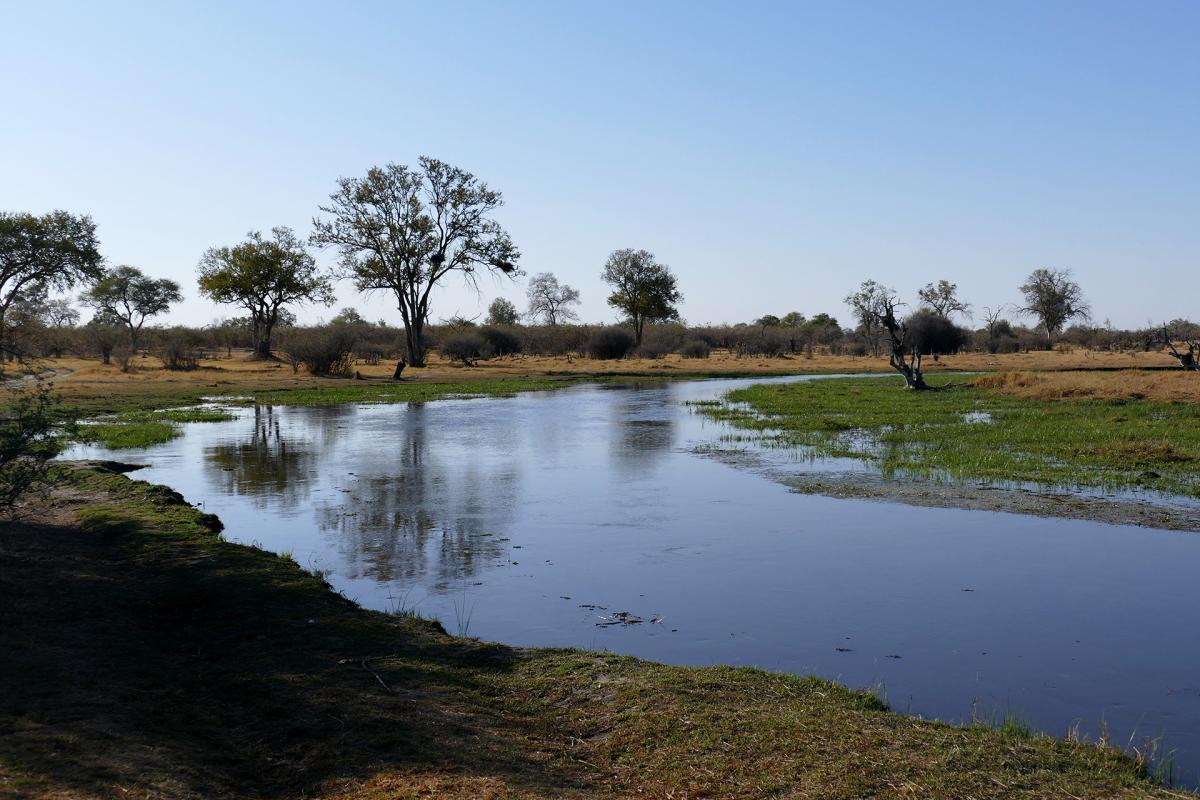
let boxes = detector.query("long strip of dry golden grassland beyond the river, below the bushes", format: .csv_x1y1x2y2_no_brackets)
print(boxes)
30,350,1177,414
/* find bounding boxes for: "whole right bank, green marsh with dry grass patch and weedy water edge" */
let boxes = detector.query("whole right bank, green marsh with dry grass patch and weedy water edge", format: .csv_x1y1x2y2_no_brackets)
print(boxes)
700,371,1200,530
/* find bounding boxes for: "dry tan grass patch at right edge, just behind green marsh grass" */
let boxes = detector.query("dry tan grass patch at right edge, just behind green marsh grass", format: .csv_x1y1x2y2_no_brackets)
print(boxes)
974,369,1200,403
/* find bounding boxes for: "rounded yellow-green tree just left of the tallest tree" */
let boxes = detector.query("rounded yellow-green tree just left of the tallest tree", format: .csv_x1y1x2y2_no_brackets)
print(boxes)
199,228,334,359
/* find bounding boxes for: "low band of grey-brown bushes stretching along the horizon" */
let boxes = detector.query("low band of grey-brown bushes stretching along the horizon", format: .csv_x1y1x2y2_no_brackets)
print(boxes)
8,302,1200,374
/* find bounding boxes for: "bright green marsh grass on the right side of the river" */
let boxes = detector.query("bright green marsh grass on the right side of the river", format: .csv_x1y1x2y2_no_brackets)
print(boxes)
700,378,1200,497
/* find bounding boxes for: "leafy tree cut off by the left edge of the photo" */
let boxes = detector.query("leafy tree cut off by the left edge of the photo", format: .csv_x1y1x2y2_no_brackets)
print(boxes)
0,211,104,364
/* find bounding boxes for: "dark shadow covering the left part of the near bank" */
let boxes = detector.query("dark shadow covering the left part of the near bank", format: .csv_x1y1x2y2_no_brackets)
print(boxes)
0,509,595,798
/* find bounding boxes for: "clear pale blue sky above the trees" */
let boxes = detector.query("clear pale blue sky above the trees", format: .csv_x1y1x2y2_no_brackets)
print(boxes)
0,0,1200,325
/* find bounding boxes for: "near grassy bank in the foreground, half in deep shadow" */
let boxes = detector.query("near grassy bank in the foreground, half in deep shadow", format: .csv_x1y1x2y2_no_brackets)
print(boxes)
0,470,1180,800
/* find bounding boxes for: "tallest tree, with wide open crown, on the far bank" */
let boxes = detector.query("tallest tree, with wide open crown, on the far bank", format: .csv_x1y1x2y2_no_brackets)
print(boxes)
310,156,521,367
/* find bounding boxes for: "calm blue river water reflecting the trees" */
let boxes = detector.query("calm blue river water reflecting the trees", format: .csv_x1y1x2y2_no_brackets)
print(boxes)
73,381,1200,784
